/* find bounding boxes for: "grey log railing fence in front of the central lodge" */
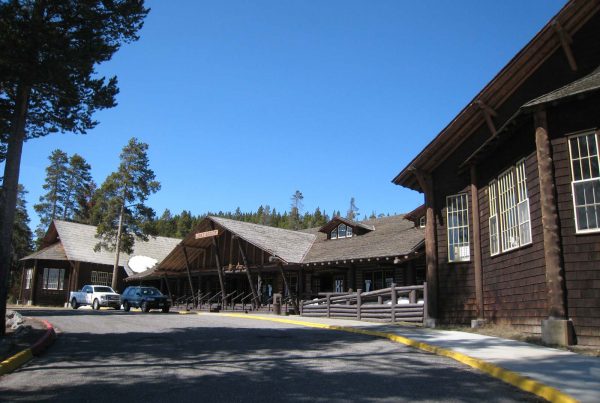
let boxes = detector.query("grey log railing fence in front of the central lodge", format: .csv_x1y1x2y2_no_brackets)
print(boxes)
300,283,427,323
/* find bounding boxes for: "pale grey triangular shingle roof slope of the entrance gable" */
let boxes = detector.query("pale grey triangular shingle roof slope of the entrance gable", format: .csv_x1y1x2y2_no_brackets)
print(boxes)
209,217,317,263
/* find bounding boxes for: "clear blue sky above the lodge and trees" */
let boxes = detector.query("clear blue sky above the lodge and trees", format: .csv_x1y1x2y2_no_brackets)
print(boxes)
15,0,565,227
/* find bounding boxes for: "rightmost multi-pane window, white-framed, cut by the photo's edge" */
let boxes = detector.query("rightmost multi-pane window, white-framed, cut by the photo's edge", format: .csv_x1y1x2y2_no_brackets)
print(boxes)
569,132,600,232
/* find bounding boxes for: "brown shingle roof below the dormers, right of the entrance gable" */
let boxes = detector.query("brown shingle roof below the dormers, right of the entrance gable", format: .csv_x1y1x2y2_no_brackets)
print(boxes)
302,215,425,263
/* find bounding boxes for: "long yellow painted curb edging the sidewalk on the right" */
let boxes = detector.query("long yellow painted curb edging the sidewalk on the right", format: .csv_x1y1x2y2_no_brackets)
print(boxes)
217,313,578,403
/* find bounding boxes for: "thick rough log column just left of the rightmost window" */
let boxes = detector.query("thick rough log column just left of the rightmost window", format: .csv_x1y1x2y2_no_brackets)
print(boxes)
535,110,567,319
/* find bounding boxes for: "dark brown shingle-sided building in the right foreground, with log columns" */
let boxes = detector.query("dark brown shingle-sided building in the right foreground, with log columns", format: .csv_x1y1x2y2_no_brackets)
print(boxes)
393,0,600,345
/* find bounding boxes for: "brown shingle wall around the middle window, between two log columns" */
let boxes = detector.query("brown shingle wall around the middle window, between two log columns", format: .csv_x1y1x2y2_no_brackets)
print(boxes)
479,140,547,334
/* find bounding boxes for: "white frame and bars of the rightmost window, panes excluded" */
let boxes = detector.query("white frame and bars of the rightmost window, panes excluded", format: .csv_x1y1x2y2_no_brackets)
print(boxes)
567,130,600,234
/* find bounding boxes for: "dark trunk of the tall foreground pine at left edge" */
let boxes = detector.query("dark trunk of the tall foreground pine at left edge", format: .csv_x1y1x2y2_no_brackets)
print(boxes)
0,84,30,337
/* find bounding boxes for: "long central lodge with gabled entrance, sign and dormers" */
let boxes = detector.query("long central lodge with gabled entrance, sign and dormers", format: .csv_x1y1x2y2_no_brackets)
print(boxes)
126,215,425,303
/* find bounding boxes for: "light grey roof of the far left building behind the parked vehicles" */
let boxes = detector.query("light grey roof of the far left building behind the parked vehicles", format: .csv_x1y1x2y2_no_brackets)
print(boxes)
22,220,180,275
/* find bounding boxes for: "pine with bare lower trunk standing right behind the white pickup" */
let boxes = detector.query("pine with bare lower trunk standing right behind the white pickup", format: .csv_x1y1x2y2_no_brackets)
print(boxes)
94,137,160,288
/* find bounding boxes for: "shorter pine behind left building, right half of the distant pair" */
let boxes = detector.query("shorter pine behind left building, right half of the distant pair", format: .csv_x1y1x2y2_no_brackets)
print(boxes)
62,154,92,221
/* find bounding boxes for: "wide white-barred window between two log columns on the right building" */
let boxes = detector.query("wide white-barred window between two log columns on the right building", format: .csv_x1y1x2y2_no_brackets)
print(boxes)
488,160,531,256
